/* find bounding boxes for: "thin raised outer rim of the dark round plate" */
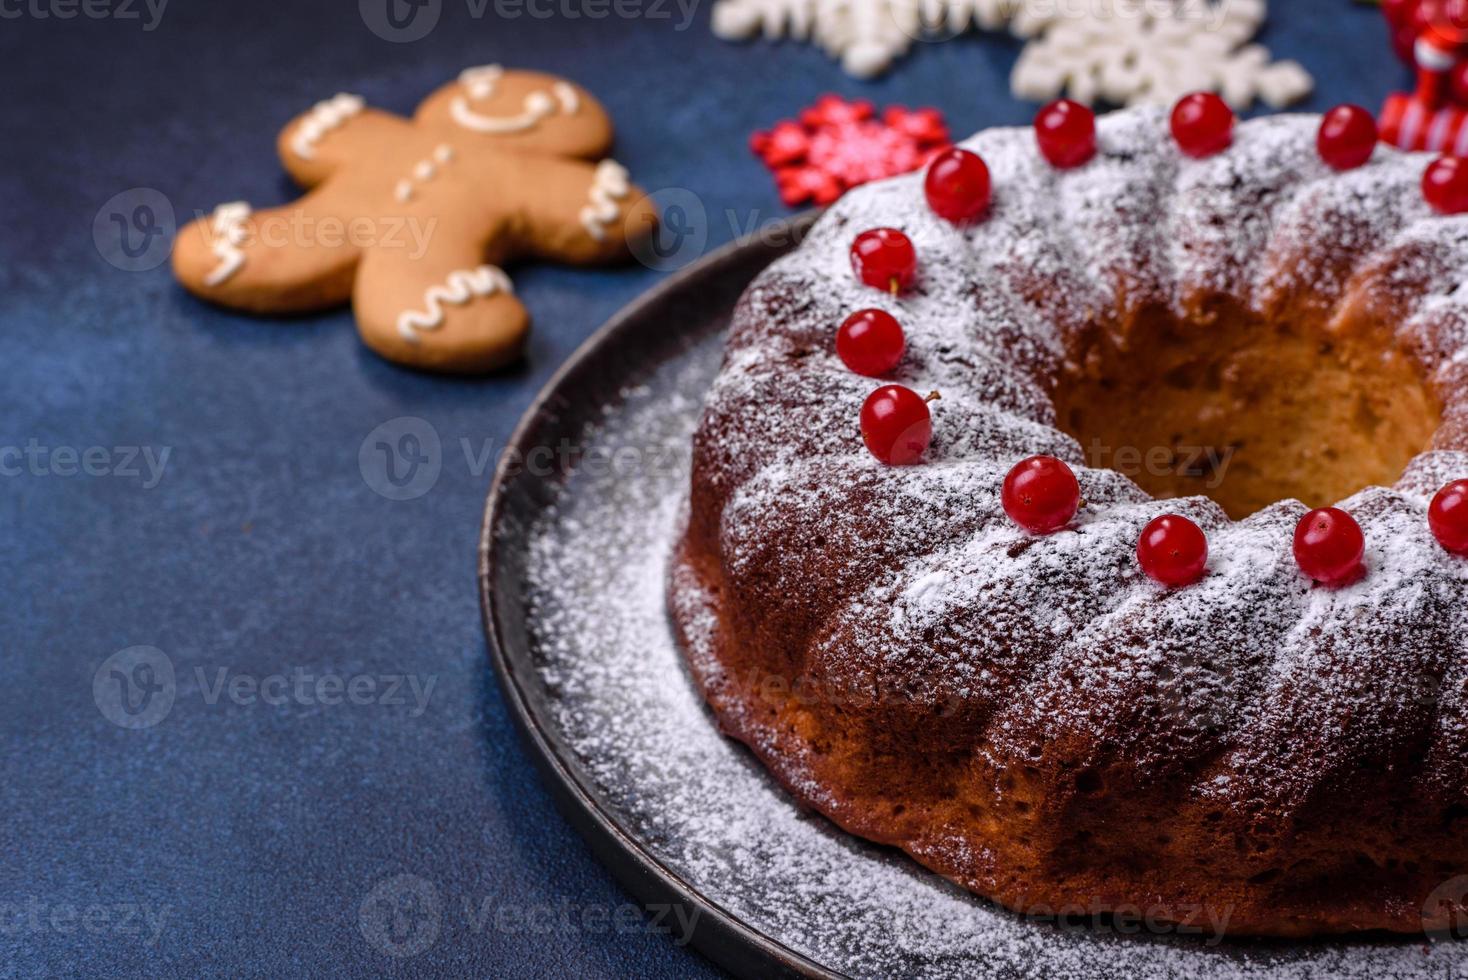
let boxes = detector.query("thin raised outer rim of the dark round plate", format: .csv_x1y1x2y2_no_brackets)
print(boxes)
476,210,844,979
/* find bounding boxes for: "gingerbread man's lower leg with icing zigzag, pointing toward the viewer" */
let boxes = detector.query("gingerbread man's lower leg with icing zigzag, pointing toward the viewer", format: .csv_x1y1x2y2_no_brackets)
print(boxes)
352,239,530,374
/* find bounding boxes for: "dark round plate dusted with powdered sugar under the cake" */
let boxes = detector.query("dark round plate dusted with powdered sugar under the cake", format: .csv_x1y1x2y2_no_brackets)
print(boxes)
479,216,1468,980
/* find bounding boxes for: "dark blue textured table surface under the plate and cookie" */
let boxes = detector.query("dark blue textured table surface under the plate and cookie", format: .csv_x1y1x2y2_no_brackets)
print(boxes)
0,0,1406,977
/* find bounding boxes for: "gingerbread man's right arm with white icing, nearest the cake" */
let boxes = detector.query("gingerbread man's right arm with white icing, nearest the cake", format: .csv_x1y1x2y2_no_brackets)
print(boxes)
496,154,658,264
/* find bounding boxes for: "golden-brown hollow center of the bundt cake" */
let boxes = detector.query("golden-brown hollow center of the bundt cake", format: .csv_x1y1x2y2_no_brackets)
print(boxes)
1055,312,1442,519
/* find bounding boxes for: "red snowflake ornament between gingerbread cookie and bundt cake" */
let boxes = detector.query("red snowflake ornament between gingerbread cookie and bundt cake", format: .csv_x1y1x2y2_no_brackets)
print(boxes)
749,95,950,207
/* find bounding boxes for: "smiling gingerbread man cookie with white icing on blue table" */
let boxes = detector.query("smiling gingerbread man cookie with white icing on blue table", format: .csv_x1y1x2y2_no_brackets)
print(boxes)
173,66,656,373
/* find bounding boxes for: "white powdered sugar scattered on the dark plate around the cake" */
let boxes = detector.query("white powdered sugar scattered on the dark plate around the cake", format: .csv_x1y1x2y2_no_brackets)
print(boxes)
526,336,1468,980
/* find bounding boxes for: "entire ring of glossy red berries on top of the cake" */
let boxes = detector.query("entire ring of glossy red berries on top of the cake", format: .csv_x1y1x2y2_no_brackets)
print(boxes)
835,92,1468,588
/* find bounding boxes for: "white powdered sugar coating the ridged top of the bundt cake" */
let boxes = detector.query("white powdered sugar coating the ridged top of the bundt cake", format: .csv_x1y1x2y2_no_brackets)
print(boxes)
692,110,1468,805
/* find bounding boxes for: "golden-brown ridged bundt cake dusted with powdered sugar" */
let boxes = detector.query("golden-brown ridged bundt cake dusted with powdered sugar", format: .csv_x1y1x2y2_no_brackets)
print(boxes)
669,109,1468,936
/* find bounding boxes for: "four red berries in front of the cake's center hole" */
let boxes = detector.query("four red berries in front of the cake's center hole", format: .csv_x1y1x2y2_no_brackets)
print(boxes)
1000,456,1468,588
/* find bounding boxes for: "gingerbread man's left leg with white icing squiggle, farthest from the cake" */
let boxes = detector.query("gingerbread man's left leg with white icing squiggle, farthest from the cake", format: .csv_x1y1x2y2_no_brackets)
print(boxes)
173,192,361,312
